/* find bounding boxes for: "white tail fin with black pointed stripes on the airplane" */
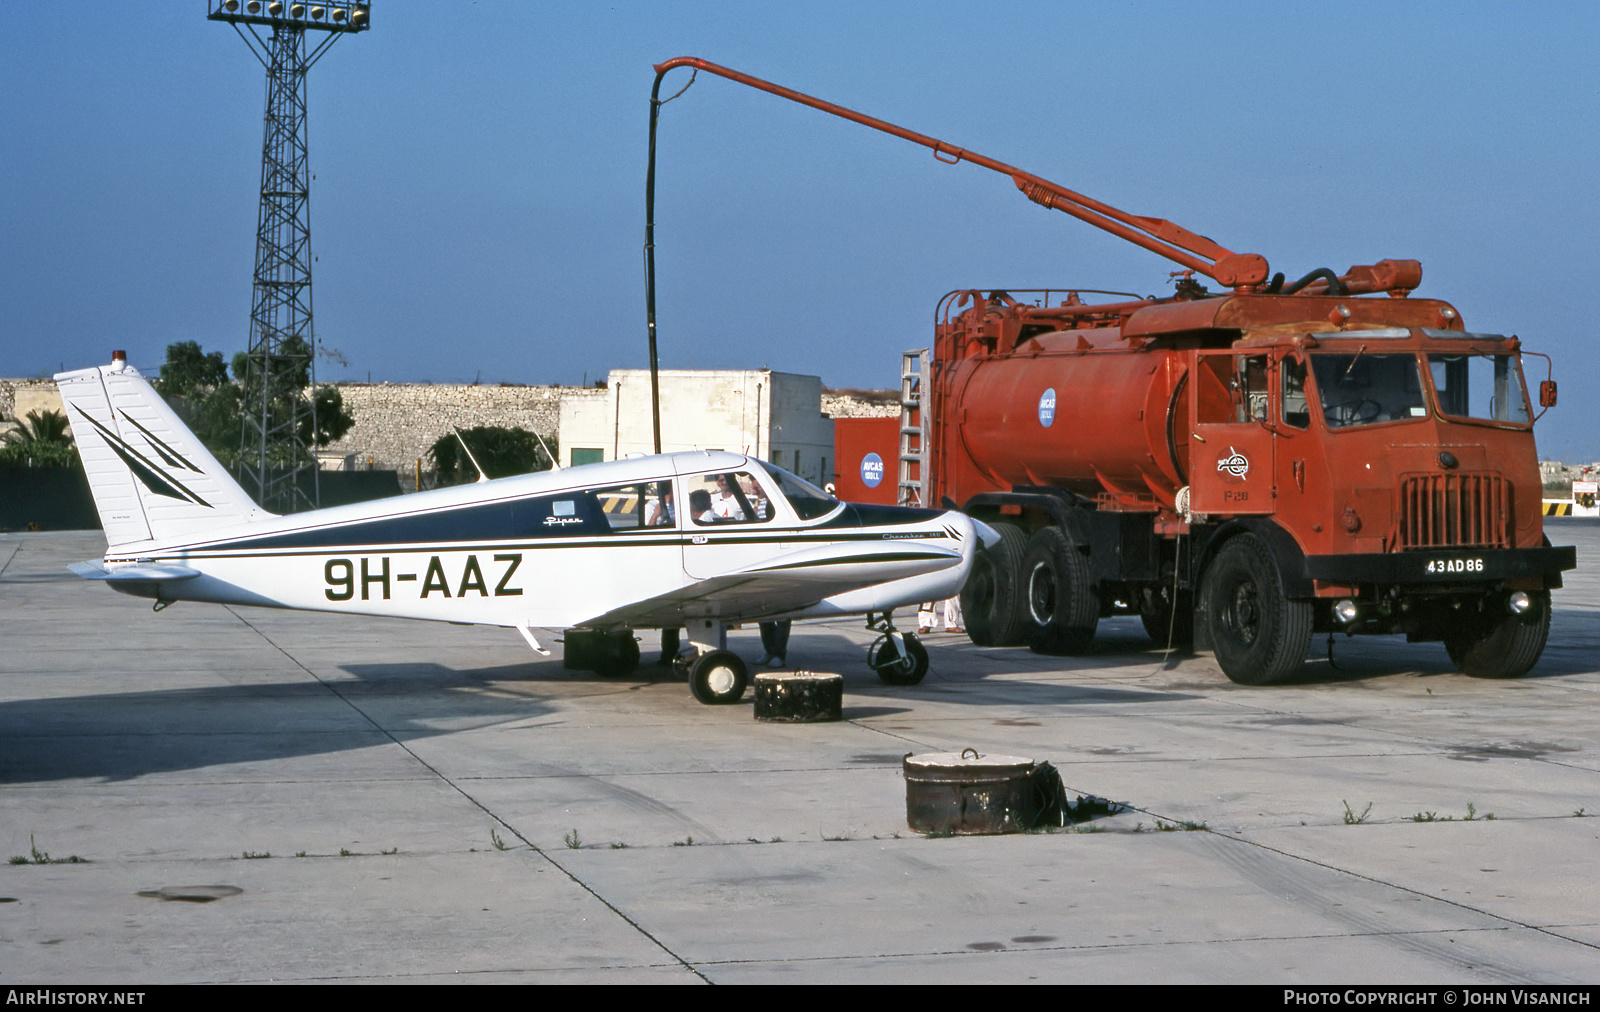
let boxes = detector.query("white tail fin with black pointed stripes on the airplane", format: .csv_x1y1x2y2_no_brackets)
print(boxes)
56,352,274,546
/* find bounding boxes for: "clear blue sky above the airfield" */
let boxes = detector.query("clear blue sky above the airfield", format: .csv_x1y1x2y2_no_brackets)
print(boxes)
0,0,1600,460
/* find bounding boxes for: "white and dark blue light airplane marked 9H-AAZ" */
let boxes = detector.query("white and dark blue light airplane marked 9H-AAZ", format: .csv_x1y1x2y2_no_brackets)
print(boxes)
56,351,998,703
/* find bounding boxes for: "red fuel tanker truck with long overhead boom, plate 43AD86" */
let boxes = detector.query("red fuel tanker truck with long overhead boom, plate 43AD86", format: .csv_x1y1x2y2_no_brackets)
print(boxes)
653,58,1576,685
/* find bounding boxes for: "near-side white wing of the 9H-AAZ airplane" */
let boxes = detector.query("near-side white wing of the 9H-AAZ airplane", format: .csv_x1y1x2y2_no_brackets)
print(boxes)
576,541,962,628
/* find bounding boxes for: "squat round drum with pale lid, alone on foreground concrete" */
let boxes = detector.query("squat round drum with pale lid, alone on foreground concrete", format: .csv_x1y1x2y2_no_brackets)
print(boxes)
902,749,1048,836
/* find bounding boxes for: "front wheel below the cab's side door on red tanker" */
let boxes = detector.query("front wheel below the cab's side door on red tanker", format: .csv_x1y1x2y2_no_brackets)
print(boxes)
1205,535,1312,685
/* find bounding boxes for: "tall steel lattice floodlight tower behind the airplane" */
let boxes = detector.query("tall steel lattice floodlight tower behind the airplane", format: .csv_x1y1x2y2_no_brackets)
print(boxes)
206,0,371,512
